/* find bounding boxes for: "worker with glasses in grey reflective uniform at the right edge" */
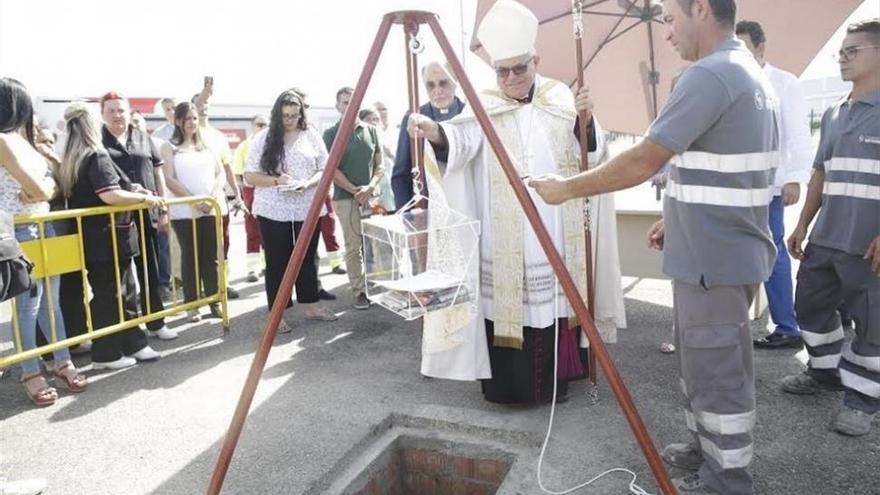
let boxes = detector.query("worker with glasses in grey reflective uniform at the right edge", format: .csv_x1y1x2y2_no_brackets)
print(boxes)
782,18,880,436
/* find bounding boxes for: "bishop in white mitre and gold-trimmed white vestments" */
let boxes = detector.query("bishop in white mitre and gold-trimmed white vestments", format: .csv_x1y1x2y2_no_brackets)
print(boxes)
407,0,626,403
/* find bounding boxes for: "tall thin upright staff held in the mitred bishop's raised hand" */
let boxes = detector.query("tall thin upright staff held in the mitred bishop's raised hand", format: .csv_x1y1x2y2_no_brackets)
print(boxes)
572,0,599,394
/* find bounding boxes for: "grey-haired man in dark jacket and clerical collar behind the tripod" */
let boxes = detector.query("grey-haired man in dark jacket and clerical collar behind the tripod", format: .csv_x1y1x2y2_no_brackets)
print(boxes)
391,62,465,209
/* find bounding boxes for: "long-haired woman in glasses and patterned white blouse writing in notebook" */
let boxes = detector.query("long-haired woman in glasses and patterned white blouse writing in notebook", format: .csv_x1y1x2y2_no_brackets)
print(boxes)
244,89,336,333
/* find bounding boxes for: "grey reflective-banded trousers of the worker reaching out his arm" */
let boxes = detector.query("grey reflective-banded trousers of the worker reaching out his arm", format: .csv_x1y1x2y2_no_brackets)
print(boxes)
673,280,758,495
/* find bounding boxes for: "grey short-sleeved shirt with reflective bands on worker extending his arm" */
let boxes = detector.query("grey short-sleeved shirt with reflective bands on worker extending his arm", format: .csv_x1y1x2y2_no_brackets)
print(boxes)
648,39,779,287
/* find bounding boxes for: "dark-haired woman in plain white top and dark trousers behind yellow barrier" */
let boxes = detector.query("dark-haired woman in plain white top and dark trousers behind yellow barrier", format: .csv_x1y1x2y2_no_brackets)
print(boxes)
161,101,226,321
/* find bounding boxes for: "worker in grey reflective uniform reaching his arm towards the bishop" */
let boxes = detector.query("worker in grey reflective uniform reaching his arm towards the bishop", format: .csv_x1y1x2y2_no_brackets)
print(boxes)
530,0,779,495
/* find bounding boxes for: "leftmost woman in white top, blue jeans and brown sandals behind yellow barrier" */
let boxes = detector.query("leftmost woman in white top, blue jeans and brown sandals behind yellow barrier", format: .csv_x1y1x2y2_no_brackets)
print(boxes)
0,78,88,407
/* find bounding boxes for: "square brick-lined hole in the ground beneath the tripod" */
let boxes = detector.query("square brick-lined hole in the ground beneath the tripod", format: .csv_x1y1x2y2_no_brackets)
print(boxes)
344,436,515,495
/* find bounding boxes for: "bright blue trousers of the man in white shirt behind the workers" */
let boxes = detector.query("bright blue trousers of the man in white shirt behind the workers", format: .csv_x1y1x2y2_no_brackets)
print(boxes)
764,196,798,335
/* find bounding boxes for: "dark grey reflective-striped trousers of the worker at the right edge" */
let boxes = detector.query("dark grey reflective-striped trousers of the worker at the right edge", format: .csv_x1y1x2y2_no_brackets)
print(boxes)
795,243,880,414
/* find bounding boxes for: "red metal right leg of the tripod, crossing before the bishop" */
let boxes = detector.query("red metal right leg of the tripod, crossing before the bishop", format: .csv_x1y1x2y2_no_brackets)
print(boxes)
426,16,677,495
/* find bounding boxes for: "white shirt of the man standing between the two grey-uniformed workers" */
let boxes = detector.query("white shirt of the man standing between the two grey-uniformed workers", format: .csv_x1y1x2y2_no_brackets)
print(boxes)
764,63,813,196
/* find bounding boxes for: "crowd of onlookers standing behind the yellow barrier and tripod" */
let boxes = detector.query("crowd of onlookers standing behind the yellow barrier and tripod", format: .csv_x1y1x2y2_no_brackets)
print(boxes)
0,63,460,406
